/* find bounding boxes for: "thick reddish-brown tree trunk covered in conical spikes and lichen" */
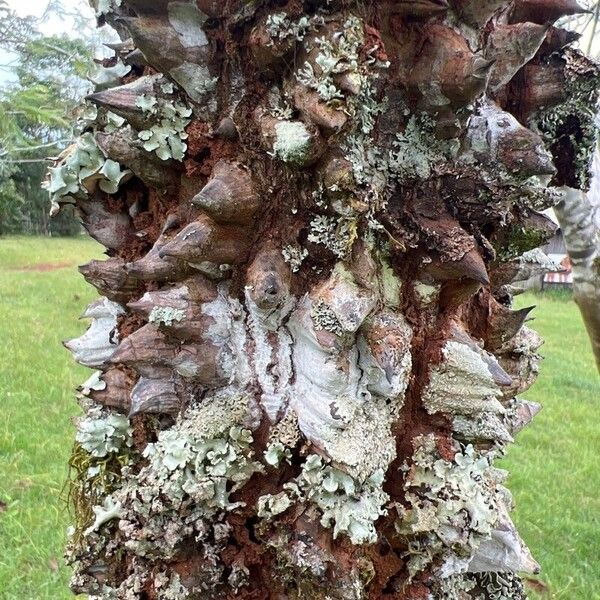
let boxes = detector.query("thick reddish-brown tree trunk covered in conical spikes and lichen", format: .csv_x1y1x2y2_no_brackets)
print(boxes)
48,0,598,600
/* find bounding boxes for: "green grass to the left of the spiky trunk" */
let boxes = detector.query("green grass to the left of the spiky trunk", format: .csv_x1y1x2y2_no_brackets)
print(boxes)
0,237,102,600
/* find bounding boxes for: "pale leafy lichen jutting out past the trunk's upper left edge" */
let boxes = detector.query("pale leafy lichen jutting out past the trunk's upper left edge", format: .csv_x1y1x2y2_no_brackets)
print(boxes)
44,132,130,205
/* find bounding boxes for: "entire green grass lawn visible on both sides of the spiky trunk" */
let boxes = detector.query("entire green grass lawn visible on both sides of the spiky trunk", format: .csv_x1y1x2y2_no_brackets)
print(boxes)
0,237,600,600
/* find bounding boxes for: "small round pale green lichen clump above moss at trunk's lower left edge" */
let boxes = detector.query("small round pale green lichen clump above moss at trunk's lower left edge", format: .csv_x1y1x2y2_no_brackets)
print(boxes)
75,406,133,458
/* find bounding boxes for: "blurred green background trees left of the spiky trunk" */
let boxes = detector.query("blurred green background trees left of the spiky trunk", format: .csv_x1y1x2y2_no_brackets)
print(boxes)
0,0,96,234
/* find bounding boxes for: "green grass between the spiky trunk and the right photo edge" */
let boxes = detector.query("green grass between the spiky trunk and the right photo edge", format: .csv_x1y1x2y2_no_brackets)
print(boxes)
503,290,600,600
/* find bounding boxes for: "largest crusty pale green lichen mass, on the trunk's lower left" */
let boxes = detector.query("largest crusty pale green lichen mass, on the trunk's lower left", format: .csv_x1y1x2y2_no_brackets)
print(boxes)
102,392,264,558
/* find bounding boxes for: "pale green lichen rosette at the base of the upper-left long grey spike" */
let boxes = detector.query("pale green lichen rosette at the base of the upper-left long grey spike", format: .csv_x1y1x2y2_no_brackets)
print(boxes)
136,92,192,160
